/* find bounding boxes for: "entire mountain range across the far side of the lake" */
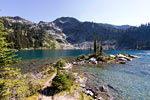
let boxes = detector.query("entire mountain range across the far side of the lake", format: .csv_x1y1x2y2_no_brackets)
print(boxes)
0,17,150,49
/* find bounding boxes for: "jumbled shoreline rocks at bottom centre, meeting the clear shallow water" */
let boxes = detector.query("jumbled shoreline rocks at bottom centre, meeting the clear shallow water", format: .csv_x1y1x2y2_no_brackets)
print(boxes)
78,72,119,100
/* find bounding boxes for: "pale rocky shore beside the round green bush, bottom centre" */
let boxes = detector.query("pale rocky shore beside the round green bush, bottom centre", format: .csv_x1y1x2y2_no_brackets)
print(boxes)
77,72,116,100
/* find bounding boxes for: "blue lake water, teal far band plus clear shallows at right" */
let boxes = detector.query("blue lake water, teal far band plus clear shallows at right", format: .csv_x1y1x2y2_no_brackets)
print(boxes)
18,50,150,100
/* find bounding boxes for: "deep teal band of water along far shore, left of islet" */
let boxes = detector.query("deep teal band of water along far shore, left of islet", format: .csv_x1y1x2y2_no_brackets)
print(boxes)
17,50,91,60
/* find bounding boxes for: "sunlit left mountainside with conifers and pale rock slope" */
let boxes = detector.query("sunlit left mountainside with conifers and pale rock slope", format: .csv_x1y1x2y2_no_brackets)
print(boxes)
0,16,74,49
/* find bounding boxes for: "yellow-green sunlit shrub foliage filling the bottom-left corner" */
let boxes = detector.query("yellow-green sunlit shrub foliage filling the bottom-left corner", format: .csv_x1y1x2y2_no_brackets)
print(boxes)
0,67,29,100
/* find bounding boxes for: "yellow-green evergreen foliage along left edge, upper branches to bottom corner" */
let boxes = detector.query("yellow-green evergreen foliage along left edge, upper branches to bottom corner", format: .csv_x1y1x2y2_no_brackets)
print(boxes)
0,23,28,100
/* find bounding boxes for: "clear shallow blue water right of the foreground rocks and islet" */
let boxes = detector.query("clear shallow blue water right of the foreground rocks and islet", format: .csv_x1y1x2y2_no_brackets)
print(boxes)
72,51,150,100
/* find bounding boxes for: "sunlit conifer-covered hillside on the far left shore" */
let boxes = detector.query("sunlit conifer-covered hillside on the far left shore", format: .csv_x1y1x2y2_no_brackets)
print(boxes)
2,18,58,49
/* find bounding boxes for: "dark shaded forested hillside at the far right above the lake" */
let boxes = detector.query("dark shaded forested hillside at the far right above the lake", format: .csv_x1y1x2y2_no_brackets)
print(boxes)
118,24,150,50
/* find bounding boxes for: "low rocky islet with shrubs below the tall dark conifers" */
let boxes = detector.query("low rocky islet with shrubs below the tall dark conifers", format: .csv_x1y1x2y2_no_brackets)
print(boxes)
73,53,139,65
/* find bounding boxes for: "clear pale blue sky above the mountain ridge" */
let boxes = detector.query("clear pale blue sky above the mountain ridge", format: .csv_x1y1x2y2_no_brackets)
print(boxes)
0,0,150,25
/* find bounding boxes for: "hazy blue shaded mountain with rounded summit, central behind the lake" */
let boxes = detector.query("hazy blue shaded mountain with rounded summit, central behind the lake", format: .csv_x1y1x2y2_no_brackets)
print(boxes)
39,17,130,49
